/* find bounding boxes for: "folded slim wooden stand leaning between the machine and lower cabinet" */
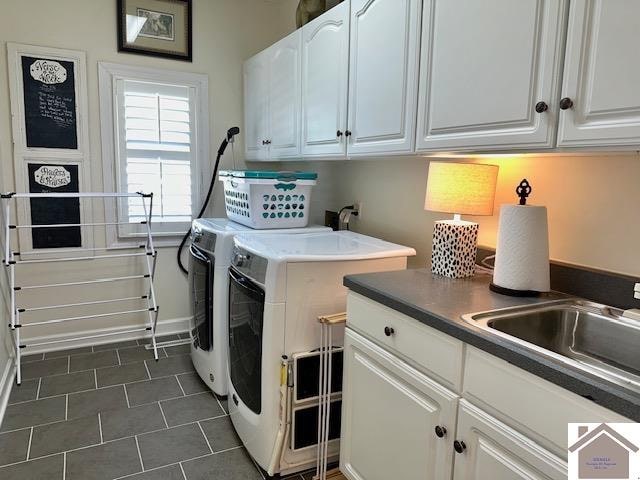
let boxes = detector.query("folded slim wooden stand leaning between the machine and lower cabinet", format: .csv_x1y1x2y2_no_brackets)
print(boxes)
313,313,347,480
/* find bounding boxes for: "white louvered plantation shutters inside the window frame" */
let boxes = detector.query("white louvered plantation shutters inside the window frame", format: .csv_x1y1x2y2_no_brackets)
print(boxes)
117,80,195,227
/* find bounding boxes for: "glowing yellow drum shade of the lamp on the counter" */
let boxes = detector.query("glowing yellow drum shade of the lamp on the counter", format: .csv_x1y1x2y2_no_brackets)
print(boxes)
424,162,498,215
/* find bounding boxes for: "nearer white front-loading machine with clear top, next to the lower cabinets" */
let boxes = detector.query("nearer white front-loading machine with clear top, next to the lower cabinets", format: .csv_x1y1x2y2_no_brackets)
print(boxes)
229,231,416,475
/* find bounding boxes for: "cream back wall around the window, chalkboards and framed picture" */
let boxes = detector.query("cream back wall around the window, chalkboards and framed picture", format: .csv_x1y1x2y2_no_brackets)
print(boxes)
0,0,297,344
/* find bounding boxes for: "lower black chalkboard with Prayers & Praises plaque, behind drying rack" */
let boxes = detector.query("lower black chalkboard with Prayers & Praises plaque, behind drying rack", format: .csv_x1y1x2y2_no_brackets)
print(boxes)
29,163,82,249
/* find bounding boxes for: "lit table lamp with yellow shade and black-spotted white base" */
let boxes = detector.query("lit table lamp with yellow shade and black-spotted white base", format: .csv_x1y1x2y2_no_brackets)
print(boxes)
424,162,498,278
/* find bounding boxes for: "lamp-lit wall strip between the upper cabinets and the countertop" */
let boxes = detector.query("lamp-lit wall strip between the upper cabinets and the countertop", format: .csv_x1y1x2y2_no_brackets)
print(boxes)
333,153,640,276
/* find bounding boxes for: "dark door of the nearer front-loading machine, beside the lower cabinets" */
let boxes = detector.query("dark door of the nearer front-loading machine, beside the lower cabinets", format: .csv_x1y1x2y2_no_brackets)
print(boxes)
229,267,264,414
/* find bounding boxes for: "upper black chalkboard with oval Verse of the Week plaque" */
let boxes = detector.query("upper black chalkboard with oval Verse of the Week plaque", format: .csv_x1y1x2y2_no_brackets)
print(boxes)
22,56,78,150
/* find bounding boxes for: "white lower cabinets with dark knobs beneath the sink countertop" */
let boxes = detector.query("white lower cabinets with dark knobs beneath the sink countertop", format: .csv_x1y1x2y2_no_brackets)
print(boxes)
340,292,616,480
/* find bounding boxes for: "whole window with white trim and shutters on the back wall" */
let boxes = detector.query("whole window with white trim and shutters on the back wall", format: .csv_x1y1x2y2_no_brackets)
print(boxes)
99,63,208,244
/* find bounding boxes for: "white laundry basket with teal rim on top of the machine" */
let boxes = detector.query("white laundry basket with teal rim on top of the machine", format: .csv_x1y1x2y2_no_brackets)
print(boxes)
219,170,318,229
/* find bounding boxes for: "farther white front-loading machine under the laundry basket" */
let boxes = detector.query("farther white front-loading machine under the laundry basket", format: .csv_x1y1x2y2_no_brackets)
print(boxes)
189,218,331,395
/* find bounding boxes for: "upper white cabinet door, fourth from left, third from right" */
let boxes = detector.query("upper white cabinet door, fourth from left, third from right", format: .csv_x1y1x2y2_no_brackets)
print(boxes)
347,0,422,155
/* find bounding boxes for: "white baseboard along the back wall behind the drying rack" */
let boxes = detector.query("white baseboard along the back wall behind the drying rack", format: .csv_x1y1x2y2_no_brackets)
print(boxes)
21,317,190,355
